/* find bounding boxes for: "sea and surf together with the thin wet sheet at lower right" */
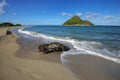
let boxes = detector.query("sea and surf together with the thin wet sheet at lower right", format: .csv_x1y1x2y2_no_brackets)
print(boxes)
14,26,120,80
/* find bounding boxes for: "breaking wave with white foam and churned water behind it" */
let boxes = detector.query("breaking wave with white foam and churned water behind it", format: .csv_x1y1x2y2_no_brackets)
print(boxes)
18,28,120,63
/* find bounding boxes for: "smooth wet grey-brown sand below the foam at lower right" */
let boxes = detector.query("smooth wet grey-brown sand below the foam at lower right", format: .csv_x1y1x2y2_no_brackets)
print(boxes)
64,54,120,80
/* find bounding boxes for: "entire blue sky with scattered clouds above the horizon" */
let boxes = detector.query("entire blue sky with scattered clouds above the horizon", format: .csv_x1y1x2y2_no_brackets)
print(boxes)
0,0,120,25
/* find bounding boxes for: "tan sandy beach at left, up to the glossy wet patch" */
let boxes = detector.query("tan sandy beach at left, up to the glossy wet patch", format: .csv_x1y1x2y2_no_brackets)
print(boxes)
0,28,77,80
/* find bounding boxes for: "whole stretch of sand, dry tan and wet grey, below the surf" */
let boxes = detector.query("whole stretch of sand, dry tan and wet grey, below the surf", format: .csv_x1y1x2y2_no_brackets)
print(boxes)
0,27,120,80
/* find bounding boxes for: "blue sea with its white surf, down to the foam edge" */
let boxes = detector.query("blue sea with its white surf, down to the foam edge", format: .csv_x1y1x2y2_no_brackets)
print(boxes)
18,25,120,63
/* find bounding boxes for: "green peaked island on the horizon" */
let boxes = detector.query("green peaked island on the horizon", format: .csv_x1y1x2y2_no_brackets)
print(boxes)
63,15,94,26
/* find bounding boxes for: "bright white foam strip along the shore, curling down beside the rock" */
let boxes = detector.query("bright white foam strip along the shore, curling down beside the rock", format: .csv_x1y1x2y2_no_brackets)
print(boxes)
18,28,120,63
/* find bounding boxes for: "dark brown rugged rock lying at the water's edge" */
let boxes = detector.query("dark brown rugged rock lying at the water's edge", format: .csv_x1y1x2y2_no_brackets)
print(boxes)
38,42,70,54
